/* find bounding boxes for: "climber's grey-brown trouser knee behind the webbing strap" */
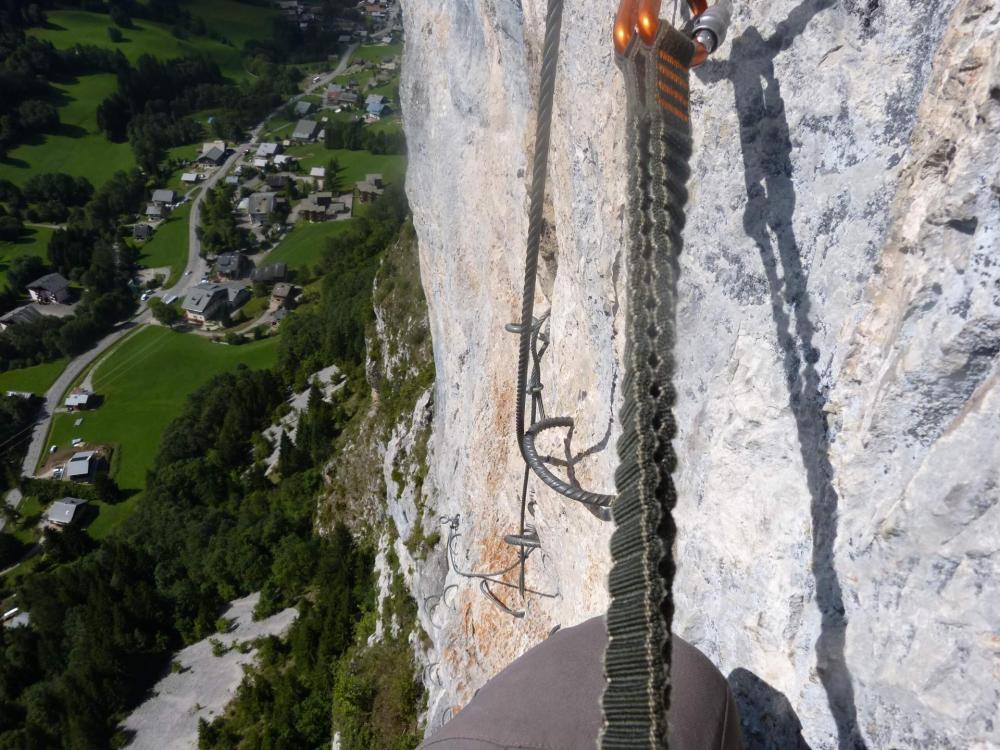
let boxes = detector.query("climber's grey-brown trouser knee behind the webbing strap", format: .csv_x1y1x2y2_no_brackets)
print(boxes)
421,617,743,750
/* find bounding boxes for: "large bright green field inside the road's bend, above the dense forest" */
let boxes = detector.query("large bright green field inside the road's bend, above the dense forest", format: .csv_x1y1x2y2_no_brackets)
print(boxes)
47,326,278,537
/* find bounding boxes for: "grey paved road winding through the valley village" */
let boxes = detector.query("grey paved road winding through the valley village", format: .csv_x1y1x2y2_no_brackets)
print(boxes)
0,38,376,530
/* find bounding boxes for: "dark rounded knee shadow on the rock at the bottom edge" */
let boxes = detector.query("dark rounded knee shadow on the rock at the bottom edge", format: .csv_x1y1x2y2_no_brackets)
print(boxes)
729,668,811,750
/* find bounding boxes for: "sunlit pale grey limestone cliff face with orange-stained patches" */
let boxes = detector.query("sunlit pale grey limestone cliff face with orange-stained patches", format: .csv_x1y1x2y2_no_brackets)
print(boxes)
397,0,1000,748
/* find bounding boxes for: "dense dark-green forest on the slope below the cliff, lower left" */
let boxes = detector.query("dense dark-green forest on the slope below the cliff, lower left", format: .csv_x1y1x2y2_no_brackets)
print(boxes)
0,191,420,748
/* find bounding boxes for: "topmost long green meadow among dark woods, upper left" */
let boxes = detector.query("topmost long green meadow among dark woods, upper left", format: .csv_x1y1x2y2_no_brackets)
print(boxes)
31,9,275,79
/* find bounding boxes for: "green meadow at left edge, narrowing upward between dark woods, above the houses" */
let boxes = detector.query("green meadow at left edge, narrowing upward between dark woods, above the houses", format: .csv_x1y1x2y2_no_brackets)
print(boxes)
0,73,135,188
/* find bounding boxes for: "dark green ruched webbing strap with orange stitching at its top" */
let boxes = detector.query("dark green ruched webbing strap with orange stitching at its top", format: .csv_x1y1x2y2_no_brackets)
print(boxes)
600,23,694,750
